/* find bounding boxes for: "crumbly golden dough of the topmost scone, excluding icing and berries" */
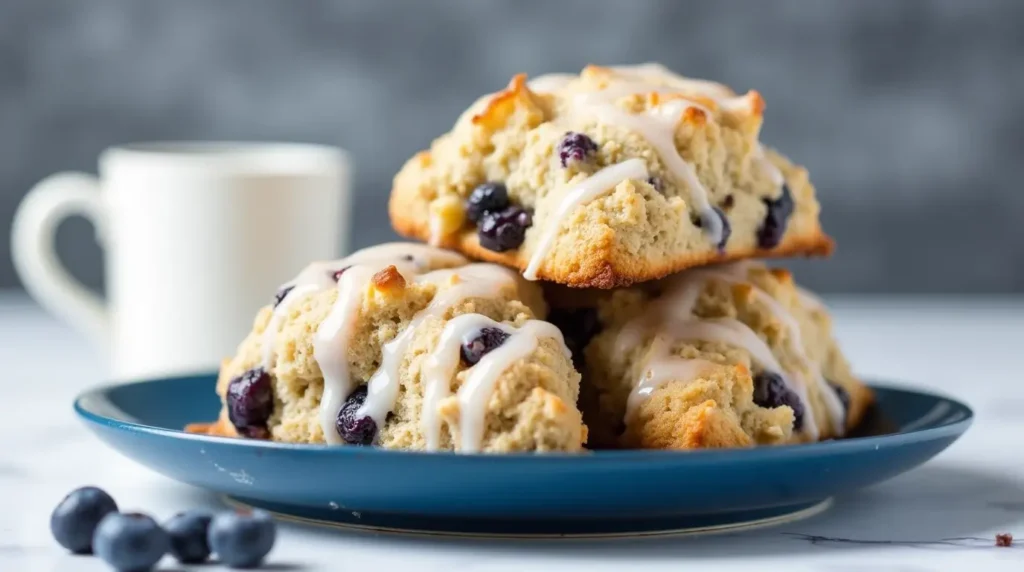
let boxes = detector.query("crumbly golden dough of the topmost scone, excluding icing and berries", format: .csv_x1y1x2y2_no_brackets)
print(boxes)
389,65,833,289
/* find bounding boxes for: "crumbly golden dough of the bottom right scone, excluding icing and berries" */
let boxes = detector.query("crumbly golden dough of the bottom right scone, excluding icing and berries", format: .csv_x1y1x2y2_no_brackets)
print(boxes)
549,263,873,449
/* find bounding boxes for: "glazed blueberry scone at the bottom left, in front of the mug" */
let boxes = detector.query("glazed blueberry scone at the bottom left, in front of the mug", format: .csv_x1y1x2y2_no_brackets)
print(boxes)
191,244,586,452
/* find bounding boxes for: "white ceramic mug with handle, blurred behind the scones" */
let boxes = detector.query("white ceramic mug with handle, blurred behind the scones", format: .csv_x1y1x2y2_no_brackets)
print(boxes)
11,142,351,379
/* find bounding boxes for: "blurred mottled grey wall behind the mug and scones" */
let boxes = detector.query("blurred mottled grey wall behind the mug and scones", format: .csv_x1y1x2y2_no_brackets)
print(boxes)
0,0,1024,293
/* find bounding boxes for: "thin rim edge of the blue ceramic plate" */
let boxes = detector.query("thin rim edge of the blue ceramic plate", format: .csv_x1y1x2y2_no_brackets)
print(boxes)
74,373,975,463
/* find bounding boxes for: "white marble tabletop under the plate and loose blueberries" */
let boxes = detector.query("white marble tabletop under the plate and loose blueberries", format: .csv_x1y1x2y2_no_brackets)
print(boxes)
0,294,1024,572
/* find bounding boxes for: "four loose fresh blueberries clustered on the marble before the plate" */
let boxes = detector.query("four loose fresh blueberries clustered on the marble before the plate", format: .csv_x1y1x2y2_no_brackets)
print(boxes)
50,487,276,572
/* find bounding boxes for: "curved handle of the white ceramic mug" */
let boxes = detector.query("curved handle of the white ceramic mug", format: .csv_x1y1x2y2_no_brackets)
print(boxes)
11,172,110,348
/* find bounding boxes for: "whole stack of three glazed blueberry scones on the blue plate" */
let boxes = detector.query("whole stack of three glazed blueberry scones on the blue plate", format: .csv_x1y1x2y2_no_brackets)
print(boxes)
197,64,871,452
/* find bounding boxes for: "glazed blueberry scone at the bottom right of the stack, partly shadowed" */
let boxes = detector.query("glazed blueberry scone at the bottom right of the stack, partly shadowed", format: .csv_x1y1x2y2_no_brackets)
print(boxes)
549,261,872,449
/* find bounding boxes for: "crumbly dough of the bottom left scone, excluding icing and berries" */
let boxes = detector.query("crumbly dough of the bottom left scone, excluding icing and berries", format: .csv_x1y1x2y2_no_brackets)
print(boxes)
207,266,586,452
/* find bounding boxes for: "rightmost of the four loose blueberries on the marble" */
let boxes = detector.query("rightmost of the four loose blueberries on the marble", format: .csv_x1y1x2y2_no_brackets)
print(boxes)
207,511,276,568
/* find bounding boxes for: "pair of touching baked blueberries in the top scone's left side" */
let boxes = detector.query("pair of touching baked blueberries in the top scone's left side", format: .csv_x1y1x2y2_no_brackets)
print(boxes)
466,182,534,252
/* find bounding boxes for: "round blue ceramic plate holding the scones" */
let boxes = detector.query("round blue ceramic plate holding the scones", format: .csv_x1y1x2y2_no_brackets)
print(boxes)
75,376,973,537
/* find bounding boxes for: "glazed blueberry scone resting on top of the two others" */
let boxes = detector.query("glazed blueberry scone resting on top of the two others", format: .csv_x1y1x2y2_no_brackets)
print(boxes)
390,64,833,289
